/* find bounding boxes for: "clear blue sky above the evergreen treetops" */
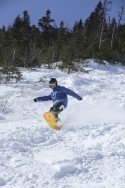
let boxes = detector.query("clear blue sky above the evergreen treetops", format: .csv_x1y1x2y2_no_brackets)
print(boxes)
0,0,123,27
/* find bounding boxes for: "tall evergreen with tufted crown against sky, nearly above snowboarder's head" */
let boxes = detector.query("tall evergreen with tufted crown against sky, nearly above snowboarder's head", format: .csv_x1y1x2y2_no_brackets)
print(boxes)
38,10,57,68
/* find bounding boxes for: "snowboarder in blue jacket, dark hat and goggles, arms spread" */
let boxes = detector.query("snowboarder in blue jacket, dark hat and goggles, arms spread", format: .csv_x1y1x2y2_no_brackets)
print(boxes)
34,78,82,121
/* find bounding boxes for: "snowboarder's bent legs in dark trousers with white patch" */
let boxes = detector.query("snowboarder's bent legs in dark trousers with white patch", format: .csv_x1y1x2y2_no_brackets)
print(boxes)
50,102,64,121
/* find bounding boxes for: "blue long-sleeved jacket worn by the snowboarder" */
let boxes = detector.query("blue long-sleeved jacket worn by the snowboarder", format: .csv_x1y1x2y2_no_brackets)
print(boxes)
34,85,82,107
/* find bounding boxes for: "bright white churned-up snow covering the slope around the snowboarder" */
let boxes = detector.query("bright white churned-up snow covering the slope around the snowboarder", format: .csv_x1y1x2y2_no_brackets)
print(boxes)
0,60,125,188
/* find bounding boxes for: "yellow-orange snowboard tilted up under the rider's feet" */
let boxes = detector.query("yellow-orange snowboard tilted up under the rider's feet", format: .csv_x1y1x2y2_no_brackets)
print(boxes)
43,112,60,130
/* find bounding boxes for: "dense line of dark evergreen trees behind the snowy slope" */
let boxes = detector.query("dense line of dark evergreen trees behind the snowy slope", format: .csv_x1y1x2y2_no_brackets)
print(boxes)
0,0,125,81
